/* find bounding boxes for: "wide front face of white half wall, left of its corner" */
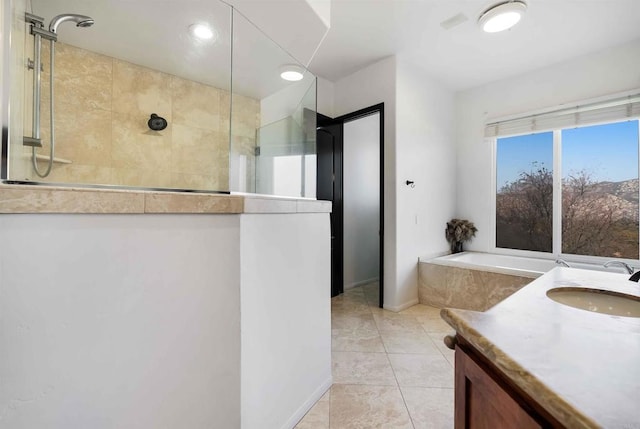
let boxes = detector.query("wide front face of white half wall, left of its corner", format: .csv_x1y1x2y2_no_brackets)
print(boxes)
0,215,242,429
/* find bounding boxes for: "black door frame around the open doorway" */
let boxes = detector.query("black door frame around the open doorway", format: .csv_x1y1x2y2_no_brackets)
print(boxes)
334,103,385,308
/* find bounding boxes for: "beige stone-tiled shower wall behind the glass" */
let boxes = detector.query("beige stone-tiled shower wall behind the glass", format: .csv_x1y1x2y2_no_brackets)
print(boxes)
33,43,260,191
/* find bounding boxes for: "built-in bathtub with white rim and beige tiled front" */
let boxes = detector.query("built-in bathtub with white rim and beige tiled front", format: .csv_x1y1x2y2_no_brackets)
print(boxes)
418,252,626,311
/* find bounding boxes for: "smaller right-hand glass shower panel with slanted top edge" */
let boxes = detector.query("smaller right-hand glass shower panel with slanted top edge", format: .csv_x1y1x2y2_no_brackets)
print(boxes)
230,10,316,198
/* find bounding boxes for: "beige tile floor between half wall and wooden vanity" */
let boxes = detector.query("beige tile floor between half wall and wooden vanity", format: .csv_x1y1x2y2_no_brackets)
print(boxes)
296,283,453,429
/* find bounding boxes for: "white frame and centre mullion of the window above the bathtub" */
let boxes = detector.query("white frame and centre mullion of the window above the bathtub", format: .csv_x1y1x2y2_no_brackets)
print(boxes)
485,117,640,267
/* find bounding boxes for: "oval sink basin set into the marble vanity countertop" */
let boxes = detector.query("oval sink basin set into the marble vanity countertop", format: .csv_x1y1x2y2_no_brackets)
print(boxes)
547,287,640,317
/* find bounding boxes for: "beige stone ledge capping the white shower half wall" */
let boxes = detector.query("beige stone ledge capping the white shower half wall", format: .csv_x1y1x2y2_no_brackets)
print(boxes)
0,184,331,214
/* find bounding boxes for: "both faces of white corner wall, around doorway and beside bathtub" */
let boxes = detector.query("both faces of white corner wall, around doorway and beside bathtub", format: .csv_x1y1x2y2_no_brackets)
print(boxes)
334,57,456,311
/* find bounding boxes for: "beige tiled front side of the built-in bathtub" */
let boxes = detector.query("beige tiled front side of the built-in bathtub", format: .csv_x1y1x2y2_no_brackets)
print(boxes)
418,262,533,311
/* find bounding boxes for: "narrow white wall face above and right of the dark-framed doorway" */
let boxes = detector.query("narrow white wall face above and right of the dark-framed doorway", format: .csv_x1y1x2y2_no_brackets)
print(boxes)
333,57,397,307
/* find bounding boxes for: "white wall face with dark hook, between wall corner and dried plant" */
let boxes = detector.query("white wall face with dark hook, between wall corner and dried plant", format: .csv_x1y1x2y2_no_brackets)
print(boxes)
396,59,456,306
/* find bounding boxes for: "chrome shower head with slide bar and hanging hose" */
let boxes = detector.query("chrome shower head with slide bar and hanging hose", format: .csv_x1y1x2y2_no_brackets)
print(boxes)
23,13,94,178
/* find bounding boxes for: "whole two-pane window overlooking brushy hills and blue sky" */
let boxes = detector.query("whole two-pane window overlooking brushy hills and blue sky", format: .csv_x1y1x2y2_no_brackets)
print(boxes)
496,120,640,259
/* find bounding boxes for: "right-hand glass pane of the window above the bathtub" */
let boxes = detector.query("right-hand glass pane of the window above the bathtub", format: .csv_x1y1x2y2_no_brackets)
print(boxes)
561,121,638,259
